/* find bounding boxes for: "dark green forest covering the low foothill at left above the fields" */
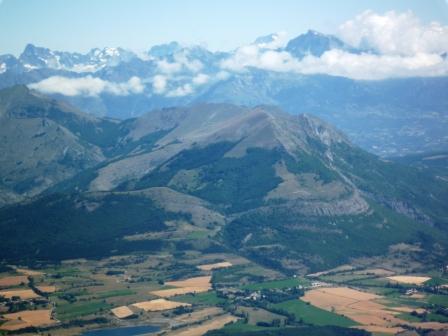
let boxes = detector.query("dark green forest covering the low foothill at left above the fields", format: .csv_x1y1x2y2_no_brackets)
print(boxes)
0,194,189,262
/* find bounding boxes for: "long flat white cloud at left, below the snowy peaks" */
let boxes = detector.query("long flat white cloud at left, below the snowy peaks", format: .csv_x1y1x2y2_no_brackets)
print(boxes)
28,75,144,97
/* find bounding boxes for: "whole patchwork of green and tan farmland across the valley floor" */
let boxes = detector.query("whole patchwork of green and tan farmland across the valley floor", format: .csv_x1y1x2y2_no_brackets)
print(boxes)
0,251,448,336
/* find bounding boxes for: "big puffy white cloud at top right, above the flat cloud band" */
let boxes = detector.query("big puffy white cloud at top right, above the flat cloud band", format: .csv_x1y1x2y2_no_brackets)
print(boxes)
339,11,448,56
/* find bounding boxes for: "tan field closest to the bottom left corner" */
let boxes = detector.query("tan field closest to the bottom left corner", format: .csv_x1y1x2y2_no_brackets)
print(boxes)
1,309,58,331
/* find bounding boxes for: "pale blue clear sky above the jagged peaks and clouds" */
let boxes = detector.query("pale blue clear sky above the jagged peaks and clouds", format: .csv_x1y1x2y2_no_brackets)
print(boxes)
0,0,448,55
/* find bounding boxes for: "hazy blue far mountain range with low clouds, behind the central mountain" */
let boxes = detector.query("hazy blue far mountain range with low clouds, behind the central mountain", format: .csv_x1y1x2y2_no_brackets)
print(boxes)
0,31,448,156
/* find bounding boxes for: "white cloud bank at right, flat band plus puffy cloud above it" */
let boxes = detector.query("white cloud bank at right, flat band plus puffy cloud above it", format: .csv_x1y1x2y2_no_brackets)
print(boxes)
221,11,448,80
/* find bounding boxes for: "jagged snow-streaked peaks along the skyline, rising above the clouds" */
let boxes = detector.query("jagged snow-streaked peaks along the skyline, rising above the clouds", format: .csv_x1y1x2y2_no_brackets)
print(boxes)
0,30,361,75
